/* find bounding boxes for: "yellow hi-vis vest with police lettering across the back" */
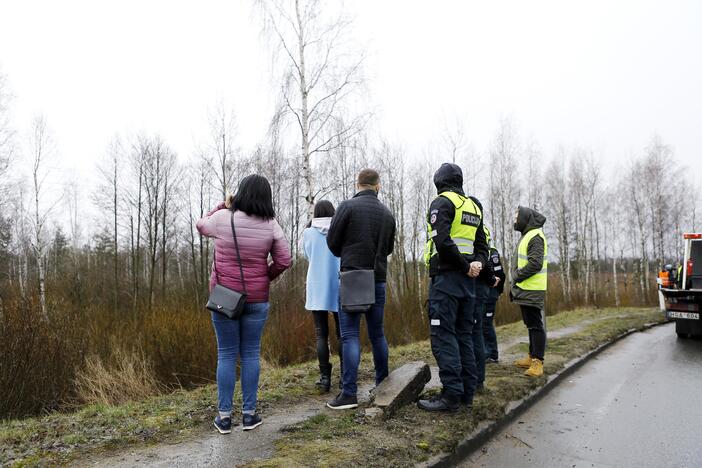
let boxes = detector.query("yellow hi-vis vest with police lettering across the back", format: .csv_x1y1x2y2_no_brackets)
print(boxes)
424,192,483,265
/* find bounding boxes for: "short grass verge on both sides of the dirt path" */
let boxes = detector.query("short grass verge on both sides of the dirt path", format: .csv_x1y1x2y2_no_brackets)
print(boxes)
0,309,661,466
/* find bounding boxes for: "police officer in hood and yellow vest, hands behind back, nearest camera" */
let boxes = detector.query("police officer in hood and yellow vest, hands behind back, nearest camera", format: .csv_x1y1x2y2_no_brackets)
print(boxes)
417,163,488,412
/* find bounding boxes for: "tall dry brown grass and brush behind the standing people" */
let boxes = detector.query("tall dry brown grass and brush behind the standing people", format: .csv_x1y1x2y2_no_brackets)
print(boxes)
0,262,655,418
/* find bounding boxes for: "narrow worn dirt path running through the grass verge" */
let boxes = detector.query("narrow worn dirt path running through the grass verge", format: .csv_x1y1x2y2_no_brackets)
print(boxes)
86,317,612,467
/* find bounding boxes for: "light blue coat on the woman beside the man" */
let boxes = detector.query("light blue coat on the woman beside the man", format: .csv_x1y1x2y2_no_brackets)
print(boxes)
302,218,340,312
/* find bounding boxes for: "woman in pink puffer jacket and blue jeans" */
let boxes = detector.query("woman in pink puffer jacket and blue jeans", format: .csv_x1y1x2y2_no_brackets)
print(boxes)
197,174,291,434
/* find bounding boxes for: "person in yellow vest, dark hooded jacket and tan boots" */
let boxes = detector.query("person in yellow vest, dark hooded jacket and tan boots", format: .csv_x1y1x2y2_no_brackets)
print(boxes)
510,206,548,377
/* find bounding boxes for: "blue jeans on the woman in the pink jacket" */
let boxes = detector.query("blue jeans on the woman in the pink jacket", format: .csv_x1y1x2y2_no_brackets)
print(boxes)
212,302,269,414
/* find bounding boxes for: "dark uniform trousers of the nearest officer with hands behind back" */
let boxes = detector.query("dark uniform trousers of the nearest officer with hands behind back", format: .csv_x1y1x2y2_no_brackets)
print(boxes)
429,271,478,403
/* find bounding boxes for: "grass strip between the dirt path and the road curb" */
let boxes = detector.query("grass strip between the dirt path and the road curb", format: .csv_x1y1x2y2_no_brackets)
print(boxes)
249,309,663,467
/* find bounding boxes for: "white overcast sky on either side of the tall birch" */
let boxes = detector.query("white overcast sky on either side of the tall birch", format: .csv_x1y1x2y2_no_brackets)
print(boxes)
0,0,702,189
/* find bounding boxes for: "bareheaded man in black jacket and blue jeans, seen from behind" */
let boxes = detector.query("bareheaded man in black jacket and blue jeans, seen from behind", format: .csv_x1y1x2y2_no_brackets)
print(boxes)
327,169,395,409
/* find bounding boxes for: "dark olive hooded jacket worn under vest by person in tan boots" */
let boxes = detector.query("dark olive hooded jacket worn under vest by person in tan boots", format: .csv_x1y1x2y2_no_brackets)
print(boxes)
510,206,546,310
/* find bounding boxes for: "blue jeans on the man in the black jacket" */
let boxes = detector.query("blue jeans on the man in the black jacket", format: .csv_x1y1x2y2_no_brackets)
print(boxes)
339,283,388,396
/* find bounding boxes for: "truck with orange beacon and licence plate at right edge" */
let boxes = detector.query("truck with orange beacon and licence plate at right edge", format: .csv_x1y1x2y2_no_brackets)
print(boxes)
657,233,702,338
